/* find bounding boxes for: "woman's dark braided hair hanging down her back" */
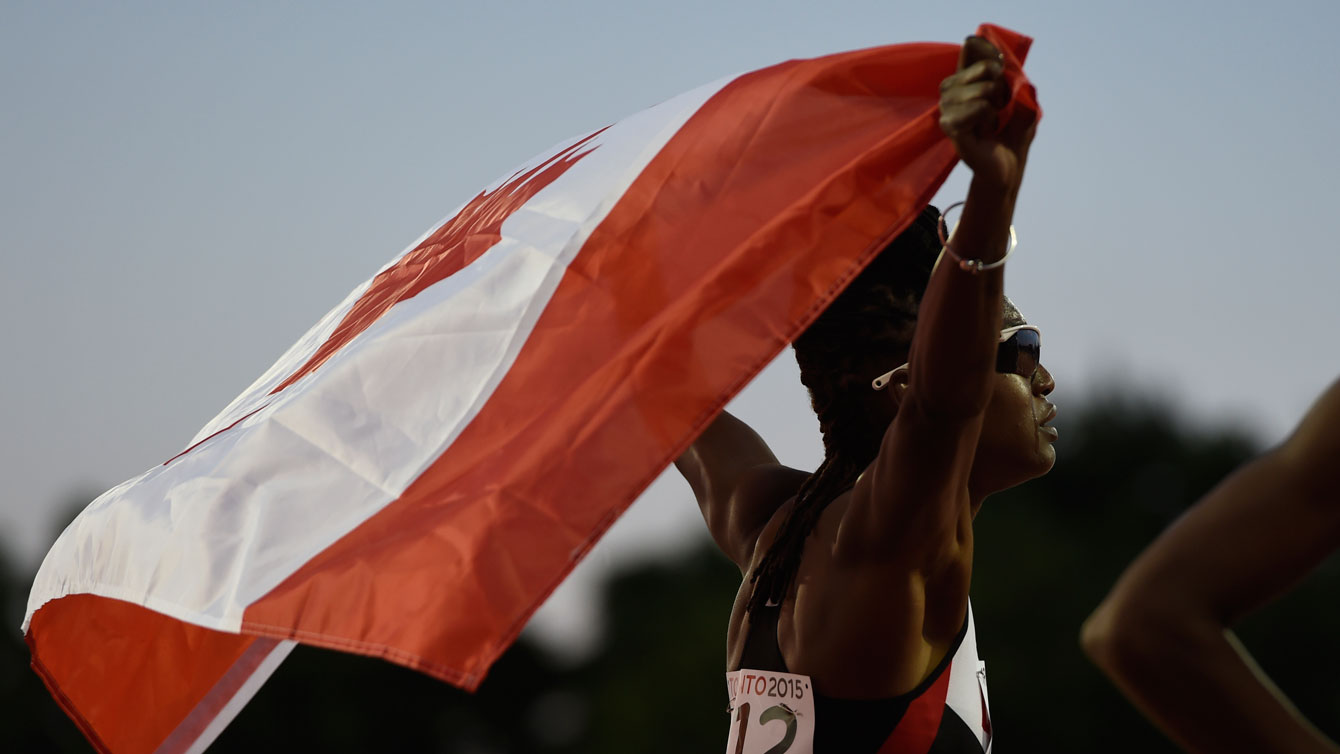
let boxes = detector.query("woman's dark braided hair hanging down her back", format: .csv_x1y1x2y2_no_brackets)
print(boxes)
746,206,939,612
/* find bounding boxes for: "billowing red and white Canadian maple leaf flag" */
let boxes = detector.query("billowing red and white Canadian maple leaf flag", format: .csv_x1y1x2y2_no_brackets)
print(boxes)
24,27,1034,753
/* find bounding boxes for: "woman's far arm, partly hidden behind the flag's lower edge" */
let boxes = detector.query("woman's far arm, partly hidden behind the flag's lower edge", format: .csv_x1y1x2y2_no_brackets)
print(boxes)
674,411,807,572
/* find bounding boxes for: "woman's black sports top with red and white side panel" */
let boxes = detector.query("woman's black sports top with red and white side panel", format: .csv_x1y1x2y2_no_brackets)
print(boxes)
740,605,992,754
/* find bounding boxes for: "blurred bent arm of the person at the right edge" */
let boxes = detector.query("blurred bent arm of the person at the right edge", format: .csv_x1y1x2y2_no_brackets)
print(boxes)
1081,382,1340,754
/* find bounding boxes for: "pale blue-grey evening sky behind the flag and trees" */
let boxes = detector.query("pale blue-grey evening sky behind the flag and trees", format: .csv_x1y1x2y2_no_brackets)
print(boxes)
0,0,1340,648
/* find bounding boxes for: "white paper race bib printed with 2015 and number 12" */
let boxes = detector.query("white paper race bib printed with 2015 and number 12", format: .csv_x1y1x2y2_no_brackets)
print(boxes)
726,668,815,754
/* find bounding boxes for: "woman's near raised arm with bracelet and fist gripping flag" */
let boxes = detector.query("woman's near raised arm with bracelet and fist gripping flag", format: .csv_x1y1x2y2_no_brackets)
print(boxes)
835,37,1036,564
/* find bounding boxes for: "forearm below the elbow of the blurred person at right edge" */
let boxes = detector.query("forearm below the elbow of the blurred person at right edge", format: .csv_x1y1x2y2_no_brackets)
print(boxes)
1083,596,1340,754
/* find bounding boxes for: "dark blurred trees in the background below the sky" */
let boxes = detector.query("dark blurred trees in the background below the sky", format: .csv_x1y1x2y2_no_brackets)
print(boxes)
0,396,1340,754
